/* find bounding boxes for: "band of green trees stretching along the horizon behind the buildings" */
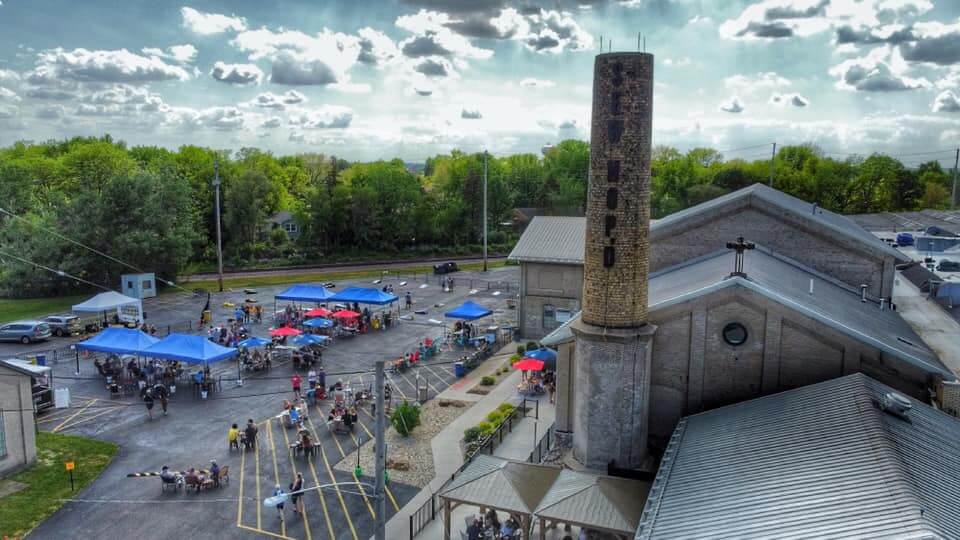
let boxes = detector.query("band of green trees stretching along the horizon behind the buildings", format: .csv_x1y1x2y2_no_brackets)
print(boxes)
0,136,950,296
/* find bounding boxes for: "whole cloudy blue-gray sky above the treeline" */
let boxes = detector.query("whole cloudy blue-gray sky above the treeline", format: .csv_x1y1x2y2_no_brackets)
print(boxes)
0,0,960,166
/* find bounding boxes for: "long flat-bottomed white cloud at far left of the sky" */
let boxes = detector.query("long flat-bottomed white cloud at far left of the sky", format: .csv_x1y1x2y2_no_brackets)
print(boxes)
27,47,190,84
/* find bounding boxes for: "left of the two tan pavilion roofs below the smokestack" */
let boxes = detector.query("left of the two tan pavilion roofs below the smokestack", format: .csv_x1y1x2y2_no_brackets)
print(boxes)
439,454,560,514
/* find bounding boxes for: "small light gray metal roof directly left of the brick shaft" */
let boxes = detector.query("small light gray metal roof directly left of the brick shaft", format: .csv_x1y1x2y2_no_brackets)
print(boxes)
507,216,587,264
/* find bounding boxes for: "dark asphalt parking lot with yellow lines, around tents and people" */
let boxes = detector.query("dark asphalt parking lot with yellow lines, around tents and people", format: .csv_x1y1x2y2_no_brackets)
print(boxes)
16,267,518,539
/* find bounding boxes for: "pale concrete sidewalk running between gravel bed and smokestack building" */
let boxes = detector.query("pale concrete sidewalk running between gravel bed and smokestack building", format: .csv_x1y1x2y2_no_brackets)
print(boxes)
386,344,554,540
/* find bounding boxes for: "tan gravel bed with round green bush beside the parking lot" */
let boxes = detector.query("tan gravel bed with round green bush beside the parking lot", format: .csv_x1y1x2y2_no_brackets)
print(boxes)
334,399,473,488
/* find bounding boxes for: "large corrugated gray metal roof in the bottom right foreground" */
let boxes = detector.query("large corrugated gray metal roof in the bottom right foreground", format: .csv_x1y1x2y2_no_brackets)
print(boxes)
636,374,960,540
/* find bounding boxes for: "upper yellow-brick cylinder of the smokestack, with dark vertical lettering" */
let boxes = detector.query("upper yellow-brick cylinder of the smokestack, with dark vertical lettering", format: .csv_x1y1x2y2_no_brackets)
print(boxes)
582,52,653,328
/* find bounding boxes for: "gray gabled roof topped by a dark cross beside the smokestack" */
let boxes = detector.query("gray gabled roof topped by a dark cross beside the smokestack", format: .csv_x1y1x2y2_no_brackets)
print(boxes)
541,246,956,380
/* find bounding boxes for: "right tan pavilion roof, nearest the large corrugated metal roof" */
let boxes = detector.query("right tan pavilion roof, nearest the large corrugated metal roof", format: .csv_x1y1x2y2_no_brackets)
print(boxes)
534,469,650,534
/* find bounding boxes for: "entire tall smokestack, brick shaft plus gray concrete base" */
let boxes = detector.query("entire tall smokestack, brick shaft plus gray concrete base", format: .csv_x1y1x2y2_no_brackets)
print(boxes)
572,52,656,470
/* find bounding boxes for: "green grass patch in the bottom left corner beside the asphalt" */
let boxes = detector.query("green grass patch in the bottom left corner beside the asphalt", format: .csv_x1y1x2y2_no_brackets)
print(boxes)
0,431,117,538
